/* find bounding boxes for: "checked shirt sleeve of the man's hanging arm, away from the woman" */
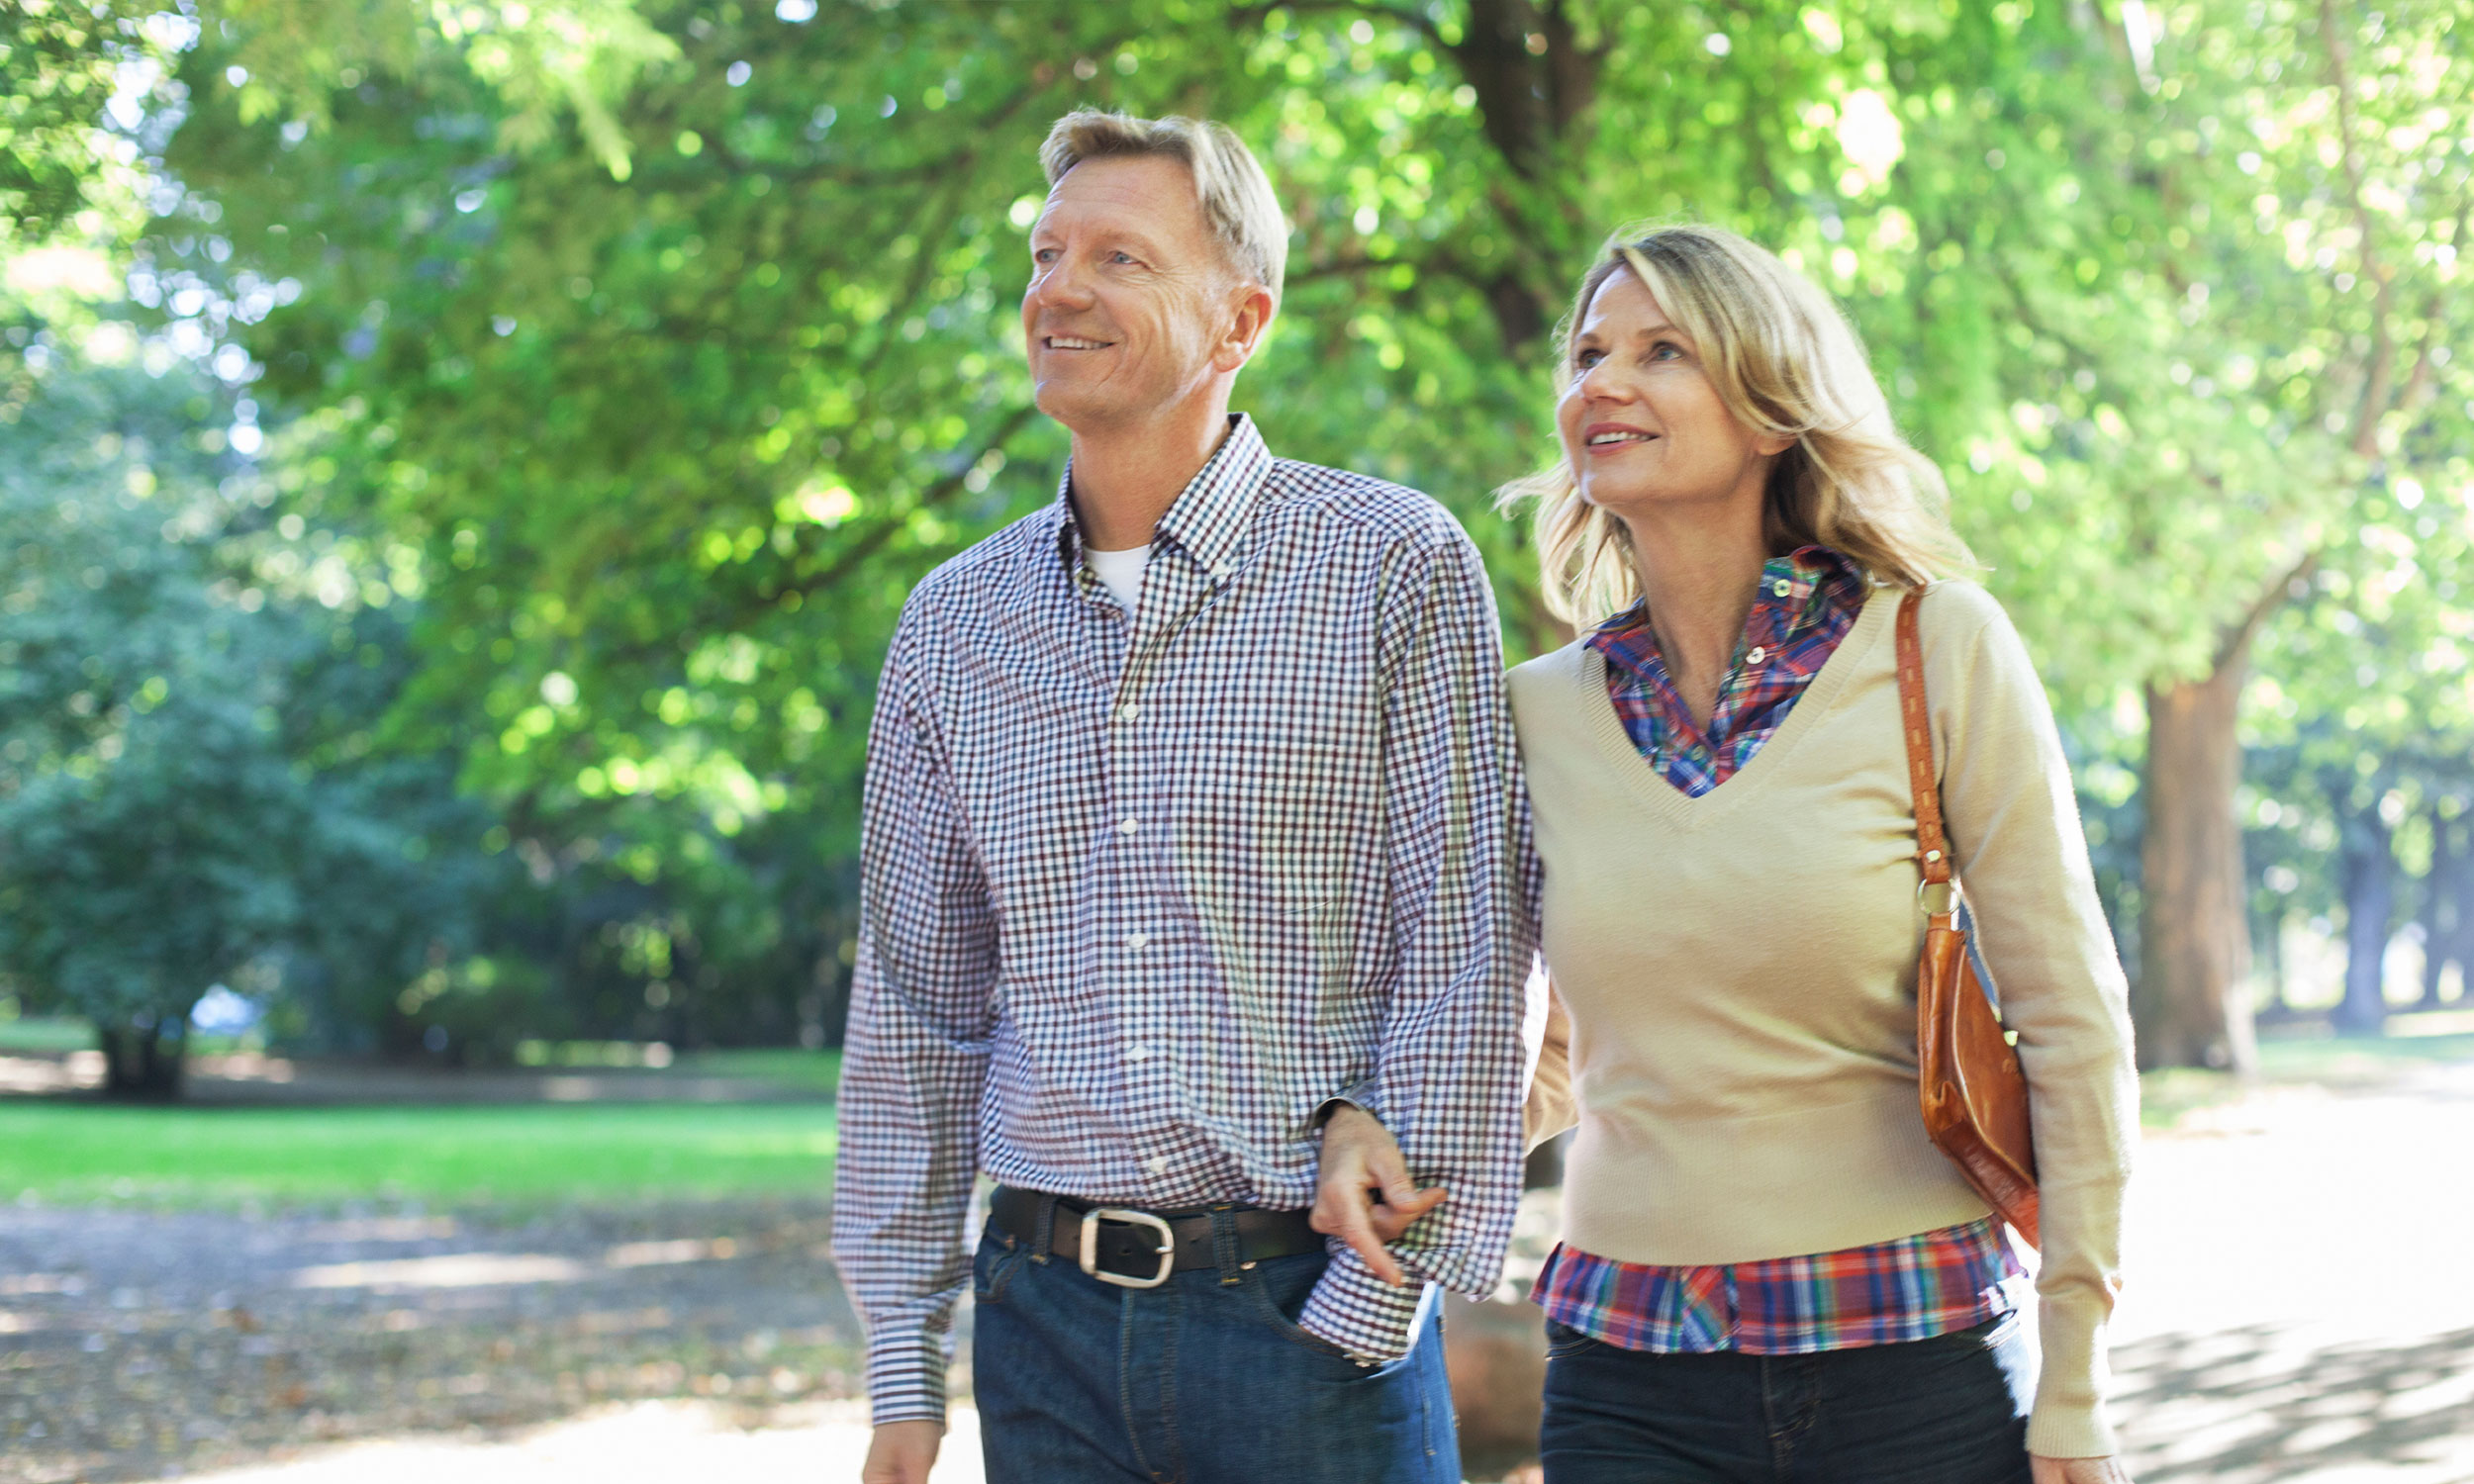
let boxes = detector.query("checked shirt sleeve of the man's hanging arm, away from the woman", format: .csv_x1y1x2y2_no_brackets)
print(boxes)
834,623,998,1423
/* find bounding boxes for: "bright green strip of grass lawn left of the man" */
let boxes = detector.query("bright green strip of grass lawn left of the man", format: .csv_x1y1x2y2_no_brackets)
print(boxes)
0,1101,834,1205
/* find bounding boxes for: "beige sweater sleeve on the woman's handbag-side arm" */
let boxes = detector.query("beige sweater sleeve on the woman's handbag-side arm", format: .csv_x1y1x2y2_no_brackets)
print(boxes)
1923,584,2138,1457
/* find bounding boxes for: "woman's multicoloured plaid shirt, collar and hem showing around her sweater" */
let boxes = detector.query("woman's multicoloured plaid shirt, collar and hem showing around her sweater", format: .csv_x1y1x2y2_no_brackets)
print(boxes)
1529,547,2022,1355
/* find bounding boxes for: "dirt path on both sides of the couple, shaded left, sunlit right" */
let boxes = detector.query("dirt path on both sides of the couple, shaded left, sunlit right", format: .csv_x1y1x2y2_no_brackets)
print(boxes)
0,1067,2474,1484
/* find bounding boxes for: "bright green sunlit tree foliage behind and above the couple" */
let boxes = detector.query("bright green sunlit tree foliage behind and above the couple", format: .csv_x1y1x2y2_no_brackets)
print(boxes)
4,0,2474,1068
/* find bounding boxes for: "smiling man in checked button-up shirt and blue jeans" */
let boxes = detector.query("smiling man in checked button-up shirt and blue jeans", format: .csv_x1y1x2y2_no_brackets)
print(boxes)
834,109,1532,1484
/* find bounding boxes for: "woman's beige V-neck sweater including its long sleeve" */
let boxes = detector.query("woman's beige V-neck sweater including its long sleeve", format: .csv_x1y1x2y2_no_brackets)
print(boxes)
1512,582,2138,1457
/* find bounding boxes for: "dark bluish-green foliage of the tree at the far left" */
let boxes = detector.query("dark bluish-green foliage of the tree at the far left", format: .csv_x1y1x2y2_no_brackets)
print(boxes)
0,295,520,1083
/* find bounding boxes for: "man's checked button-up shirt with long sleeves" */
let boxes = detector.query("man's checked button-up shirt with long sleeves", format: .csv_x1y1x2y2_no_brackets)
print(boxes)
834,418,1534,1423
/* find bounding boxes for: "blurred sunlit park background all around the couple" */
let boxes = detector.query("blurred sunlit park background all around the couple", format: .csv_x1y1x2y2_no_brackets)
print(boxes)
0,0,2474,1484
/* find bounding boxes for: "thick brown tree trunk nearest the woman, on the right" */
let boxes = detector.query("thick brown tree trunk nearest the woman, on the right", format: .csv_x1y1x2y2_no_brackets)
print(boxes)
2133,668,2259,1076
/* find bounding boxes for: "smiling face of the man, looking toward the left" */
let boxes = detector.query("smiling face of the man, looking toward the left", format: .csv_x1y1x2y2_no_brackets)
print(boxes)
1022,156,1245,433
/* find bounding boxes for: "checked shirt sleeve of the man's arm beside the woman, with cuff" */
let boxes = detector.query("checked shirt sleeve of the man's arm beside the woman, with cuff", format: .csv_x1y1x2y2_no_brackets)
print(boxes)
1299,532,1537,1360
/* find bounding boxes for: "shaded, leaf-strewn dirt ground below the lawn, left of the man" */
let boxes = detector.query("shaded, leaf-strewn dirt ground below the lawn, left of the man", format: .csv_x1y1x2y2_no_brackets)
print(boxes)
0,1205,859,1484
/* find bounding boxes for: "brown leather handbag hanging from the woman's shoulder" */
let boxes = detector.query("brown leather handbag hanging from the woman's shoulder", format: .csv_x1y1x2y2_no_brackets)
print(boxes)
1898,589,2039,1247
